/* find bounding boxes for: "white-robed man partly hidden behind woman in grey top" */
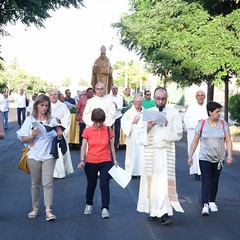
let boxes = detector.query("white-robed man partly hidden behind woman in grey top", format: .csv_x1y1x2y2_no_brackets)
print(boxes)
183,90,208,180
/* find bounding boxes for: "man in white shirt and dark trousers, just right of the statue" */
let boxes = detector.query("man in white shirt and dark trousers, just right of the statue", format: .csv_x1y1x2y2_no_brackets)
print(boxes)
110,85,123,151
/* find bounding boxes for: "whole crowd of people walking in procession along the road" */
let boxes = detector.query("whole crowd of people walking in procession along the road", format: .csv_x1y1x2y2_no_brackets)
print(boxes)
0,82,233,225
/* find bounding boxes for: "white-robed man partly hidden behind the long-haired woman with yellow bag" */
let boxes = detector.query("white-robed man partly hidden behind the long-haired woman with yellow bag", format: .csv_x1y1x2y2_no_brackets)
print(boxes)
49,90,74,178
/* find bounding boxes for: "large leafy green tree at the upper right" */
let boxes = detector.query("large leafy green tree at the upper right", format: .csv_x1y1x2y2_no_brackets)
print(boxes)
113,0,240,120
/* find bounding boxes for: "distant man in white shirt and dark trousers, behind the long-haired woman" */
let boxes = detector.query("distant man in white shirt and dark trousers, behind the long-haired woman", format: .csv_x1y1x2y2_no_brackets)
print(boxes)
17,88,27,128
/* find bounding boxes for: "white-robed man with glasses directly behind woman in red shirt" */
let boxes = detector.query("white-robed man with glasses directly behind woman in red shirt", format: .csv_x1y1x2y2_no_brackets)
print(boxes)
83,82,116,127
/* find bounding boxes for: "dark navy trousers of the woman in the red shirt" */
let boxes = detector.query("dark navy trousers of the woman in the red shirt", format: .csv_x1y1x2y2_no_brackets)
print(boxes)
84,162,113,209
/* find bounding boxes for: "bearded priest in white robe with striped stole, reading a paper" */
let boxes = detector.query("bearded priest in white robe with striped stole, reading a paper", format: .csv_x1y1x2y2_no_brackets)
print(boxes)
137,87,183,225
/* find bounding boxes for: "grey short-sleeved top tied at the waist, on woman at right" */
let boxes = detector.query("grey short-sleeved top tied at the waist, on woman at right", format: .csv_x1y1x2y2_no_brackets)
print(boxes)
196,120,230,163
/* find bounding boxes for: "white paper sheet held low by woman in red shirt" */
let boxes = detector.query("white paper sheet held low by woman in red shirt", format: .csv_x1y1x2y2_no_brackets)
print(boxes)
108,165,132,188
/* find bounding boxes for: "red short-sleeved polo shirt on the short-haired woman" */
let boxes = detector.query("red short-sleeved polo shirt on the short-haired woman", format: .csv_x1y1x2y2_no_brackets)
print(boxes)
82,125,113,164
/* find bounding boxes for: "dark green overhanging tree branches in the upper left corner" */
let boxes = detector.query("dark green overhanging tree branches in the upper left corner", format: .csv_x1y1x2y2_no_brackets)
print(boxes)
0,0,84,35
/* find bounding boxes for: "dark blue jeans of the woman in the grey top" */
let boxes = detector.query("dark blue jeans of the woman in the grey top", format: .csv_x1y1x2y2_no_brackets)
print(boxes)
199,160,222,205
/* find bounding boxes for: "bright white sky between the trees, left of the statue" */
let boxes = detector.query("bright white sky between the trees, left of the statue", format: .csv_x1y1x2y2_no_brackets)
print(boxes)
1,0,138,88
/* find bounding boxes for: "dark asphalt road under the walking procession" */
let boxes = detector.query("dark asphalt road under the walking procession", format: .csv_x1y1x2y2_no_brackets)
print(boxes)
0,113,240,240
